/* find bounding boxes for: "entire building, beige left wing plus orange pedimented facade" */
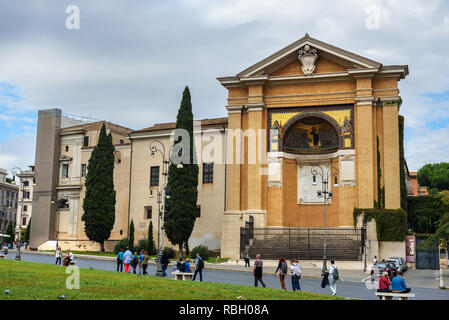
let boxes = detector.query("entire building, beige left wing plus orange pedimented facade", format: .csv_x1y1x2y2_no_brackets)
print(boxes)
31,35,408,259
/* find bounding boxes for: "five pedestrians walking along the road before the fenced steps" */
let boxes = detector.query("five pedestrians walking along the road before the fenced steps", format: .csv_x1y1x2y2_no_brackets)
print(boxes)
250,254,340,296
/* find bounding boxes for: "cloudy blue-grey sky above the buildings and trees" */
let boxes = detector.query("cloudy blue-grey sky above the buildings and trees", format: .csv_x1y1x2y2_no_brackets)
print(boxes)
0,0,449,170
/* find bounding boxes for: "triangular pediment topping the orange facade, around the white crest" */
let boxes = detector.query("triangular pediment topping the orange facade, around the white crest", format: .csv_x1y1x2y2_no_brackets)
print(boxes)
237,34,382,78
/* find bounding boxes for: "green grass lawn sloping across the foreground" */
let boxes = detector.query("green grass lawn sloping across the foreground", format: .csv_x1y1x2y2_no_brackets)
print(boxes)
0,259,344,300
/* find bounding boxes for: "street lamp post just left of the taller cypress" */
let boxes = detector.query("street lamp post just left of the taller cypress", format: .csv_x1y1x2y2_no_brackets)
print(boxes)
150,140,183,277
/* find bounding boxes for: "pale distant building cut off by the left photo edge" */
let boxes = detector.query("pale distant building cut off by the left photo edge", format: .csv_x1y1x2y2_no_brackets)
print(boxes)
0,169,19,239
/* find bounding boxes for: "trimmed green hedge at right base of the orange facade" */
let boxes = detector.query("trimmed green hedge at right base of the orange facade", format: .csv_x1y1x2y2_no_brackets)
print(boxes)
354,208,407,241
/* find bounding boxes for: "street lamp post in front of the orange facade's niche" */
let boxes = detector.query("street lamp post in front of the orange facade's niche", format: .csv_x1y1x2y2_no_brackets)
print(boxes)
311,163,338,273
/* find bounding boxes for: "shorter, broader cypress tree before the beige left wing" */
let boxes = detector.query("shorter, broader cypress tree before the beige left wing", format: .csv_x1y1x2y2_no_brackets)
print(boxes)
81,123,115,252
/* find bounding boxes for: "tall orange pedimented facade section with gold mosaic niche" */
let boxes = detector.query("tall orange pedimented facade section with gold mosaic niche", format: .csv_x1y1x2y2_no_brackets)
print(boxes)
218,35,408,258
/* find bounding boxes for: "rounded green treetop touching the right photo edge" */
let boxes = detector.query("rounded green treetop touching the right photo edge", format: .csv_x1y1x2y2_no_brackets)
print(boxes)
418,162,449,191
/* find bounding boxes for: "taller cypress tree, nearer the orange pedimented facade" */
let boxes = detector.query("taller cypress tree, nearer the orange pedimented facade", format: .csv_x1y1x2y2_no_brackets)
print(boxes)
164,87,198,257
